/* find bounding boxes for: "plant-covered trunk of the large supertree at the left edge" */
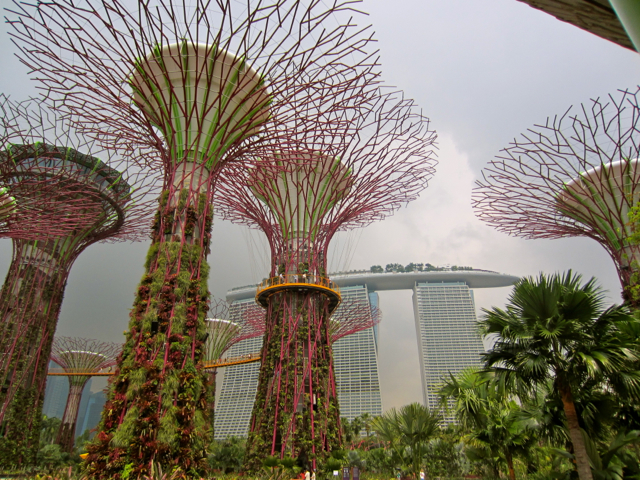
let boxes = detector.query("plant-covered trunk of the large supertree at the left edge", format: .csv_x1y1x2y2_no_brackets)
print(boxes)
0,240,75,465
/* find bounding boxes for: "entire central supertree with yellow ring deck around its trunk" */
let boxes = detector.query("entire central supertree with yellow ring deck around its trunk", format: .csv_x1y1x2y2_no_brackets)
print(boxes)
216,89,435,471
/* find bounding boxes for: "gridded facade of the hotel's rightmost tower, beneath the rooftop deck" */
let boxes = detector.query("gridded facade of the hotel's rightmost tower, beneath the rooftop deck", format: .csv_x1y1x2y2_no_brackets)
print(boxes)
413,282,484,420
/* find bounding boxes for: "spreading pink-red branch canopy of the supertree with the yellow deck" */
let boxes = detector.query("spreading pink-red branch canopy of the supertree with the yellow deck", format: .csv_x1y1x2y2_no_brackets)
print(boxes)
215,88,436,264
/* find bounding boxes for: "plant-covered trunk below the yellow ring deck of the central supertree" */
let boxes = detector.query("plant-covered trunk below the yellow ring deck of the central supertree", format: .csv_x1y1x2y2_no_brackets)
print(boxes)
245,290,342,470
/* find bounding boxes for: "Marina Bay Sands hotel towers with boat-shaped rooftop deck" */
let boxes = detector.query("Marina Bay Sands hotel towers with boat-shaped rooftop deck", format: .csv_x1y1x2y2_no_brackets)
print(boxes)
215,269,518,439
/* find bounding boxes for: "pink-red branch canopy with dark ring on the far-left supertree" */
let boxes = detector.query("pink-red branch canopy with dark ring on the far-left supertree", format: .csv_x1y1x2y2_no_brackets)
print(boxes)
0,96,161,244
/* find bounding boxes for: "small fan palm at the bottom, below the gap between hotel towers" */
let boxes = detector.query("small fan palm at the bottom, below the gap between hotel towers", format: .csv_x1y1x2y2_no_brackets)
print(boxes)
371,403,442,480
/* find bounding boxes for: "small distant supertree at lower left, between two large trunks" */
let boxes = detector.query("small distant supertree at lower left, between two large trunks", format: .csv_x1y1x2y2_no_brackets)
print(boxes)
50,337,122,452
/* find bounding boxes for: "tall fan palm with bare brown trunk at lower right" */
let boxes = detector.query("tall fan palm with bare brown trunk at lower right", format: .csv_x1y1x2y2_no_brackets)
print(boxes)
480,271,640,480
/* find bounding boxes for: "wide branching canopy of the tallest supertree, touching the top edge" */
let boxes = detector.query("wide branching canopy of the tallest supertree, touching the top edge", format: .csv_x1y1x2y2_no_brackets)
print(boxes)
9,0,377,178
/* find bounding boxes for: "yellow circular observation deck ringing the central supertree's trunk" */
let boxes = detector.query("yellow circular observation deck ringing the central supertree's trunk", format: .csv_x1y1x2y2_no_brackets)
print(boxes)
256,273,342,314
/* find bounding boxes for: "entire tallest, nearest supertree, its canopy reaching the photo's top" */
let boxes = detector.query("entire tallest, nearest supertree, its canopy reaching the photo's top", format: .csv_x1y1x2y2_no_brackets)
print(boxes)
10,0,377,472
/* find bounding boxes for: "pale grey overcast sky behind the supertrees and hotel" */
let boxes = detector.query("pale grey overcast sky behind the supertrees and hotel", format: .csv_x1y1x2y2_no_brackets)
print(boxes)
0,0,640,409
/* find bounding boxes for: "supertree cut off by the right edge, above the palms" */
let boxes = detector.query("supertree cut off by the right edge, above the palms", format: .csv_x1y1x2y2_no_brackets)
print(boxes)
473,89,640,308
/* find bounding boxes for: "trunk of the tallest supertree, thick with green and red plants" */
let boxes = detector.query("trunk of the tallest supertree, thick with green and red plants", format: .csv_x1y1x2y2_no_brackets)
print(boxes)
87,174,212,478
